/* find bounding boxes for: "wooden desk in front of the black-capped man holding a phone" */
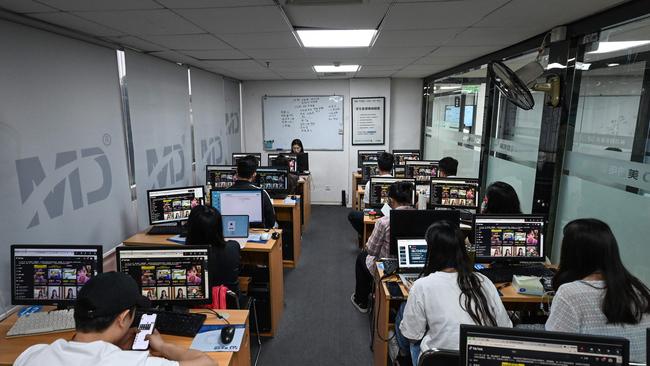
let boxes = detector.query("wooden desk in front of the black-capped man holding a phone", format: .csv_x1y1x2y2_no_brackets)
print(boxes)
0,309,251,366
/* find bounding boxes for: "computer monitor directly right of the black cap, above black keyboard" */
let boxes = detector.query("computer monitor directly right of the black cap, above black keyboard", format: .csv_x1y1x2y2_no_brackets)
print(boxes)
116,245,211,307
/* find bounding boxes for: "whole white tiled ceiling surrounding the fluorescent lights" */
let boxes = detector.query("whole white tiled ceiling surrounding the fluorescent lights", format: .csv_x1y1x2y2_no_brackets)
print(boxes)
0,0,626,80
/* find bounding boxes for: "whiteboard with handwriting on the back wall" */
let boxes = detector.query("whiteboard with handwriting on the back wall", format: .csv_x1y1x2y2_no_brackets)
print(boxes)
262,95,343,151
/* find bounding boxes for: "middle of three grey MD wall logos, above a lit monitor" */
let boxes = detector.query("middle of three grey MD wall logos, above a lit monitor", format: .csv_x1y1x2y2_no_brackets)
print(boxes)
146,143,185,189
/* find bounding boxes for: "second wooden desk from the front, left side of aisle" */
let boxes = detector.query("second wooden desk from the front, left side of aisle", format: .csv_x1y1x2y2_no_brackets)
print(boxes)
123,229,284,337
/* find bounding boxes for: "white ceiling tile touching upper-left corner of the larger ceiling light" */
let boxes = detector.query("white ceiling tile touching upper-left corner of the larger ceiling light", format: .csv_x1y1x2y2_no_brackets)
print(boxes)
175,6,292,36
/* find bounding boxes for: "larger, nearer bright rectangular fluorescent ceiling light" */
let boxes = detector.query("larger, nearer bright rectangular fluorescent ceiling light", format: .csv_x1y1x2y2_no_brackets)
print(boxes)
296,29,377,48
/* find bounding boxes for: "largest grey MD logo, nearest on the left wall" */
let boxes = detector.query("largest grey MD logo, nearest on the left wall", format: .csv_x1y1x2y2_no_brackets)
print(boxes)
16,147,113,229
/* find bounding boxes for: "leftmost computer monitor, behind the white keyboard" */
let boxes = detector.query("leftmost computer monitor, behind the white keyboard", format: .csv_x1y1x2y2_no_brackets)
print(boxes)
11,244,104,307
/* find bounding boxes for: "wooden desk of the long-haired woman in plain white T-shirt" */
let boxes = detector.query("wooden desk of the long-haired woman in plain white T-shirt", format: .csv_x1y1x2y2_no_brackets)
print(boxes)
372,269,548,366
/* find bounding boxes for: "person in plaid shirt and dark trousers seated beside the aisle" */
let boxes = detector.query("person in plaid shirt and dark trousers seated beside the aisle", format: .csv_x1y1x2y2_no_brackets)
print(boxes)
350,182,414,313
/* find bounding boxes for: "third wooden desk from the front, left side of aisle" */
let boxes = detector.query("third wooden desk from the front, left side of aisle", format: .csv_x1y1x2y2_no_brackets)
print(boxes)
273,196,302,268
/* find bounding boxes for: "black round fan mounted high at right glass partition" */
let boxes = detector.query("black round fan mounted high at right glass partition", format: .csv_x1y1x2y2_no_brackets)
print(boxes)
488,56,560,110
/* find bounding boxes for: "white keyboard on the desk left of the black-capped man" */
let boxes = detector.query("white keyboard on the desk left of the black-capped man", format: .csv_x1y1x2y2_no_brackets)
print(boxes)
7,309,75,337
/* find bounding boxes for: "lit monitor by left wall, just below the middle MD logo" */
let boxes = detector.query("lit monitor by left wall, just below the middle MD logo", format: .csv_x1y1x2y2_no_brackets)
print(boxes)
147,186,204,225
